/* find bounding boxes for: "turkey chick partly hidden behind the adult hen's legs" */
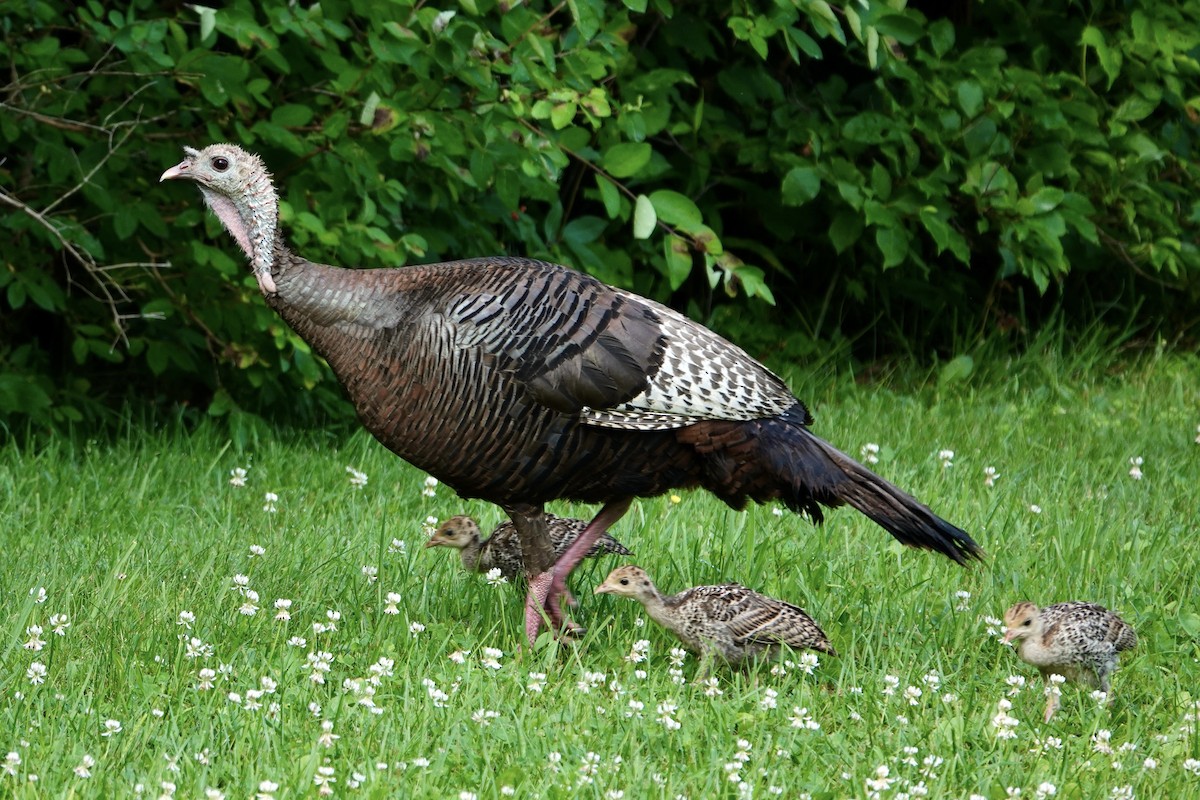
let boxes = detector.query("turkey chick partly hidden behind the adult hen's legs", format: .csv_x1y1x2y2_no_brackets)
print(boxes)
425,513,632,581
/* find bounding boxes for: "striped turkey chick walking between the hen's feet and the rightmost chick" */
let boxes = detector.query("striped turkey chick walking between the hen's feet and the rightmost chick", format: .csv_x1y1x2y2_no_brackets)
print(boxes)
595,566,838,667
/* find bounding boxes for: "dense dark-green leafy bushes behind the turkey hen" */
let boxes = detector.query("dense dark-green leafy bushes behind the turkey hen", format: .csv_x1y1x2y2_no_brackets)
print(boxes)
0,0,1200,425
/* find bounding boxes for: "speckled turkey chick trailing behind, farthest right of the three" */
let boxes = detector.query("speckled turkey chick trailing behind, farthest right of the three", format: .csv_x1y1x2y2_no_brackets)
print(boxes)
1004,601,1138,722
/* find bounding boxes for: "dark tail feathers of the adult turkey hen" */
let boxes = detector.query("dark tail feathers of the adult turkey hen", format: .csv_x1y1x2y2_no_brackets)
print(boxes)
760,419,984,564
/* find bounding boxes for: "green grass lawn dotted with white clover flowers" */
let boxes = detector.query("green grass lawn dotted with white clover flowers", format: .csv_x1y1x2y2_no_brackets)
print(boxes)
0,356,1200,799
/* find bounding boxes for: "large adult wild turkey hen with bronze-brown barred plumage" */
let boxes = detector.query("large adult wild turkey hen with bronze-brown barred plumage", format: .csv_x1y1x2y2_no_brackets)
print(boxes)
160,144,982,642
